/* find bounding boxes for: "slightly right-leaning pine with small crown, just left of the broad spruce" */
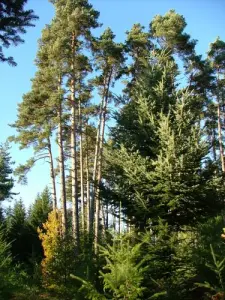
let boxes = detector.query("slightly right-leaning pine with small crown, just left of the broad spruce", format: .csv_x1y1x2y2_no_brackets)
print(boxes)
91,28,124,251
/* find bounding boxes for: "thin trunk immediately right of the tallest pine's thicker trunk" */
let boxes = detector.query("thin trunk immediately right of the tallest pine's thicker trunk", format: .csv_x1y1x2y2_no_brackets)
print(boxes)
79,99,85,230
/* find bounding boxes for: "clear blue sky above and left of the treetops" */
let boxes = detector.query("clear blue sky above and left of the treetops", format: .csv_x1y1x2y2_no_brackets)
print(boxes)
0,0,225,206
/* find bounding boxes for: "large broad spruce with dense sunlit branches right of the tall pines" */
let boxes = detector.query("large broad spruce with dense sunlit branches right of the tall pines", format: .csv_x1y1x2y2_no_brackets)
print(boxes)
106,54,223,228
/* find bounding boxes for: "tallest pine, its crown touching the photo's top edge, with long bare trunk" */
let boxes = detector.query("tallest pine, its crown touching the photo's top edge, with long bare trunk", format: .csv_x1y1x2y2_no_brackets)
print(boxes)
50,0,99,245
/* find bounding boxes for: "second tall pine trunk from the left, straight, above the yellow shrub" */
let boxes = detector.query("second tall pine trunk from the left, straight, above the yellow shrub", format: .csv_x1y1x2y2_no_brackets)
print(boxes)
58,78,67,234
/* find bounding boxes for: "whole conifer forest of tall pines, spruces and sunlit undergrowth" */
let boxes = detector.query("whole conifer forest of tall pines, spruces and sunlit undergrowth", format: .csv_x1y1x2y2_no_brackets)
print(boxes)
0,0,225,300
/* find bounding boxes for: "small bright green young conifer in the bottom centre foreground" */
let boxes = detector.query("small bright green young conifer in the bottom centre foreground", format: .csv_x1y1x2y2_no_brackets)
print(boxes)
100,236,145,300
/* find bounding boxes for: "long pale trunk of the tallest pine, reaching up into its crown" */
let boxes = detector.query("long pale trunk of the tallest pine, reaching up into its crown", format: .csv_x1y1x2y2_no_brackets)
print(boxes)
70,35,80,250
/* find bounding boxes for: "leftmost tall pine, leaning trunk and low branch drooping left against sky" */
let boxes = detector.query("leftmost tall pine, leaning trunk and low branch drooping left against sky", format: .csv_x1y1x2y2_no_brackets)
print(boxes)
10,77,57,207
